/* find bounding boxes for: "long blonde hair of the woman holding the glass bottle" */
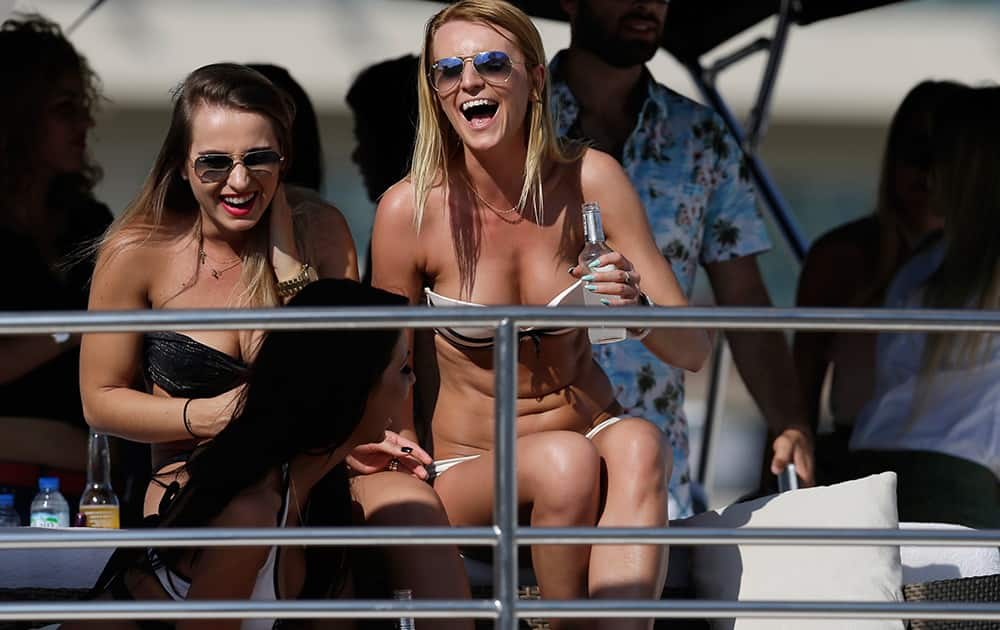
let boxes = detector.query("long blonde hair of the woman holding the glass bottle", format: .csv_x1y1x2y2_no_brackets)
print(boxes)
410,0,580,231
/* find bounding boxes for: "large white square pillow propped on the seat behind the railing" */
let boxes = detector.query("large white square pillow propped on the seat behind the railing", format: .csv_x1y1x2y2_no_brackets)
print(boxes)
675,472,903,630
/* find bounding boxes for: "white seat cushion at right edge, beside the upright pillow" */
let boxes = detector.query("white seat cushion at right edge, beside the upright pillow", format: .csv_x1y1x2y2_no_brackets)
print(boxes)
899,523,1000,584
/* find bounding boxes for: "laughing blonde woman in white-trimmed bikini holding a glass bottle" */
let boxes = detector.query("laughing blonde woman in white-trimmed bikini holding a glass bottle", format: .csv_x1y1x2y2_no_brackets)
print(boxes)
373,0,709,628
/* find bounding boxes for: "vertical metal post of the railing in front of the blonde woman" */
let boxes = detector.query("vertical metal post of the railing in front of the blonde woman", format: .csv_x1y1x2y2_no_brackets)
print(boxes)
493,318,518,630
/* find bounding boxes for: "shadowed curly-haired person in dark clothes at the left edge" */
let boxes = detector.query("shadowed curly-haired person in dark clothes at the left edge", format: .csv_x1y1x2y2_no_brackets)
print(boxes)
0,15,112,522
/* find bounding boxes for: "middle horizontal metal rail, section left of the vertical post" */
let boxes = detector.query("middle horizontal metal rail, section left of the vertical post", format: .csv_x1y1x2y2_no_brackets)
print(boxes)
0,527,497,549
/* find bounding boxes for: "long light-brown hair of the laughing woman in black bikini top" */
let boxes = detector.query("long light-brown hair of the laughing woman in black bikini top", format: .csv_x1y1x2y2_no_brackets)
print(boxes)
98,63,295,306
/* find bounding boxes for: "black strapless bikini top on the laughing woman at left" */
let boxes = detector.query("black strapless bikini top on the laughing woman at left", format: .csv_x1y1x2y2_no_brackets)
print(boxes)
143,331,248,398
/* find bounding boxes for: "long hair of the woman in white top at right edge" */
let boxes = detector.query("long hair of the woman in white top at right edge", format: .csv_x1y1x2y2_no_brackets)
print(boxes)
921,87,1000,382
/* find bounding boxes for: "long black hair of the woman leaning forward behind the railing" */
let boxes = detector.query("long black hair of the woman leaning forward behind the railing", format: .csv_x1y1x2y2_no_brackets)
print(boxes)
95,279,406,597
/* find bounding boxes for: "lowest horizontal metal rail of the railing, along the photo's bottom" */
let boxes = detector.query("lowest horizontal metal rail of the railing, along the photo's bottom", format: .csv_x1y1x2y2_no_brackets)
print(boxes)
0,600,1000,621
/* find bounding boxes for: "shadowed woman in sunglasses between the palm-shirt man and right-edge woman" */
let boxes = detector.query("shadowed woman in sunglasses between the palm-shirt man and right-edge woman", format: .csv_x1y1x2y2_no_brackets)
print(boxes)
794,81,963,483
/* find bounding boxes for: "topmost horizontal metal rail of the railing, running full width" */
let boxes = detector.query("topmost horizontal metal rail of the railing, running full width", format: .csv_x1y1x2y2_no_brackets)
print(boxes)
0,306,1000,334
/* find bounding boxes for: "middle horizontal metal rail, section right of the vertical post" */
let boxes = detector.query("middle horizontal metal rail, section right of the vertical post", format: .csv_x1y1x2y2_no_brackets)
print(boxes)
516,527,1000,547
